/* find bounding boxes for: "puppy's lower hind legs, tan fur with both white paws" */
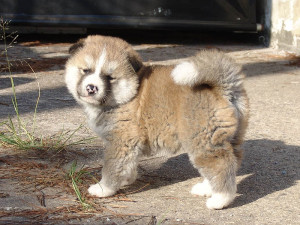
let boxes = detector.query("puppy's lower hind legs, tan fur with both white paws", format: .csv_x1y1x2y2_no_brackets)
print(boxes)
191,143,237,209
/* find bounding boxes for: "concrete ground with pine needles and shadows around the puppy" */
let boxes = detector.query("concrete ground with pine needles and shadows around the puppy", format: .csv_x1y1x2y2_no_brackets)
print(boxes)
0,31,300,225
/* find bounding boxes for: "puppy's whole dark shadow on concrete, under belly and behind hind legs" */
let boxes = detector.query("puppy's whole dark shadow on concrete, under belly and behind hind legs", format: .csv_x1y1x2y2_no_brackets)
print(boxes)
121,139,300,208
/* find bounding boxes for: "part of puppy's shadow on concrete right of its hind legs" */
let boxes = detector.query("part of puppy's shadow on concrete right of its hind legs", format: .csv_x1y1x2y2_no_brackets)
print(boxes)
231,139,300,207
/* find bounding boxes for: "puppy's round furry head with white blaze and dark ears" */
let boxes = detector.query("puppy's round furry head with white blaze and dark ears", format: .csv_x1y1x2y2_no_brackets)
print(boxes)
65,36,143,106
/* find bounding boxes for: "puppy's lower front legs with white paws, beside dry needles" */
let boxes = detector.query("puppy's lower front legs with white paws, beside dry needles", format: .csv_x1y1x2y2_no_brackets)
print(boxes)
88,146,137,197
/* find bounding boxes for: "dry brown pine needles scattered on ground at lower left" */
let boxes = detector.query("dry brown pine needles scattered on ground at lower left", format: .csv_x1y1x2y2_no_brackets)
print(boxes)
0,150,149,223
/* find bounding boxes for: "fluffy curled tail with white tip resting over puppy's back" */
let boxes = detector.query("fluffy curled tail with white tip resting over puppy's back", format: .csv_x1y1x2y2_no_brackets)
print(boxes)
171,50,244,97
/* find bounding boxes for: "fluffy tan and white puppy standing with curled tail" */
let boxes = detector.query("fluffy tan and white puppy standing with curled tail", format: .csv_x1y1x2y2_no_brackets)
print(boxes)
65,36,248,209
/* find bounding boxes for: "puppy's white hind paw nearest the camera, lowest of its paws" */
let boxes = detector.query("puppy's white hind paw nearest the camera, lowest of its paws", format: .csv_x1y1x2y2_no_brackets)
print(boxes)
206,193,235,209
